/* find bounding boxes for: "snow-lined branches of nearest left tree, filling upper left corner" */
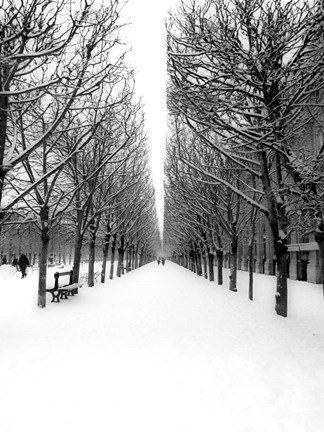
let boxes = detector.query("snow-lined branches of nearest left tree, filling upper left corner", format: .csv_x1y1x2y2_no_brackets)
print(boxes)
0,0,126,219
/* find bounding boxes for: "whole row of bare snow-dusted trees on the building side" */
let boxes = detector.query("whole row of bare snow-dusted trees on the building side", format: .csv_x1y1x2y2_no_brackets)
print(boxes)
165,0,324,316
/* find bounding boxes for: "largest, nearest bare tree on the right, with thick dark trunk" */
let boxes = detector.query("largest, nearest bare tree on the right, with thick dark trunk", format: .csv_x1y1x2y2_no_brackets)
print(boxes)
168,0,324,316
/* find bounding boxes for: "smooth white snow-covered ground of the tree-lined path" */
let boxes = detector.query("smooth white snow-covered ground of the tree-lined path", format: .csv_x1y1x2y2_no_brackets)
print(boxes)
0,261,324,432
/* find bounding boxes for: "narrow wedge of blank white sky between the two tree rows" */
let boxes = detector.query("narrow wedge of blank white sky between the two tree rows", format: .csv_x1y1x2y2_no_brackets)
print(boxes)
124,0,177,233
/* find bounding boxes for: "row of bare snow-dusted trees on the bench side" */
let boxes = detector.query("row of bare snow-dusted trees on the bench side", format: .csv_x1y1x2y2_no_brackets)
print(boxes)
0,0,159,307
